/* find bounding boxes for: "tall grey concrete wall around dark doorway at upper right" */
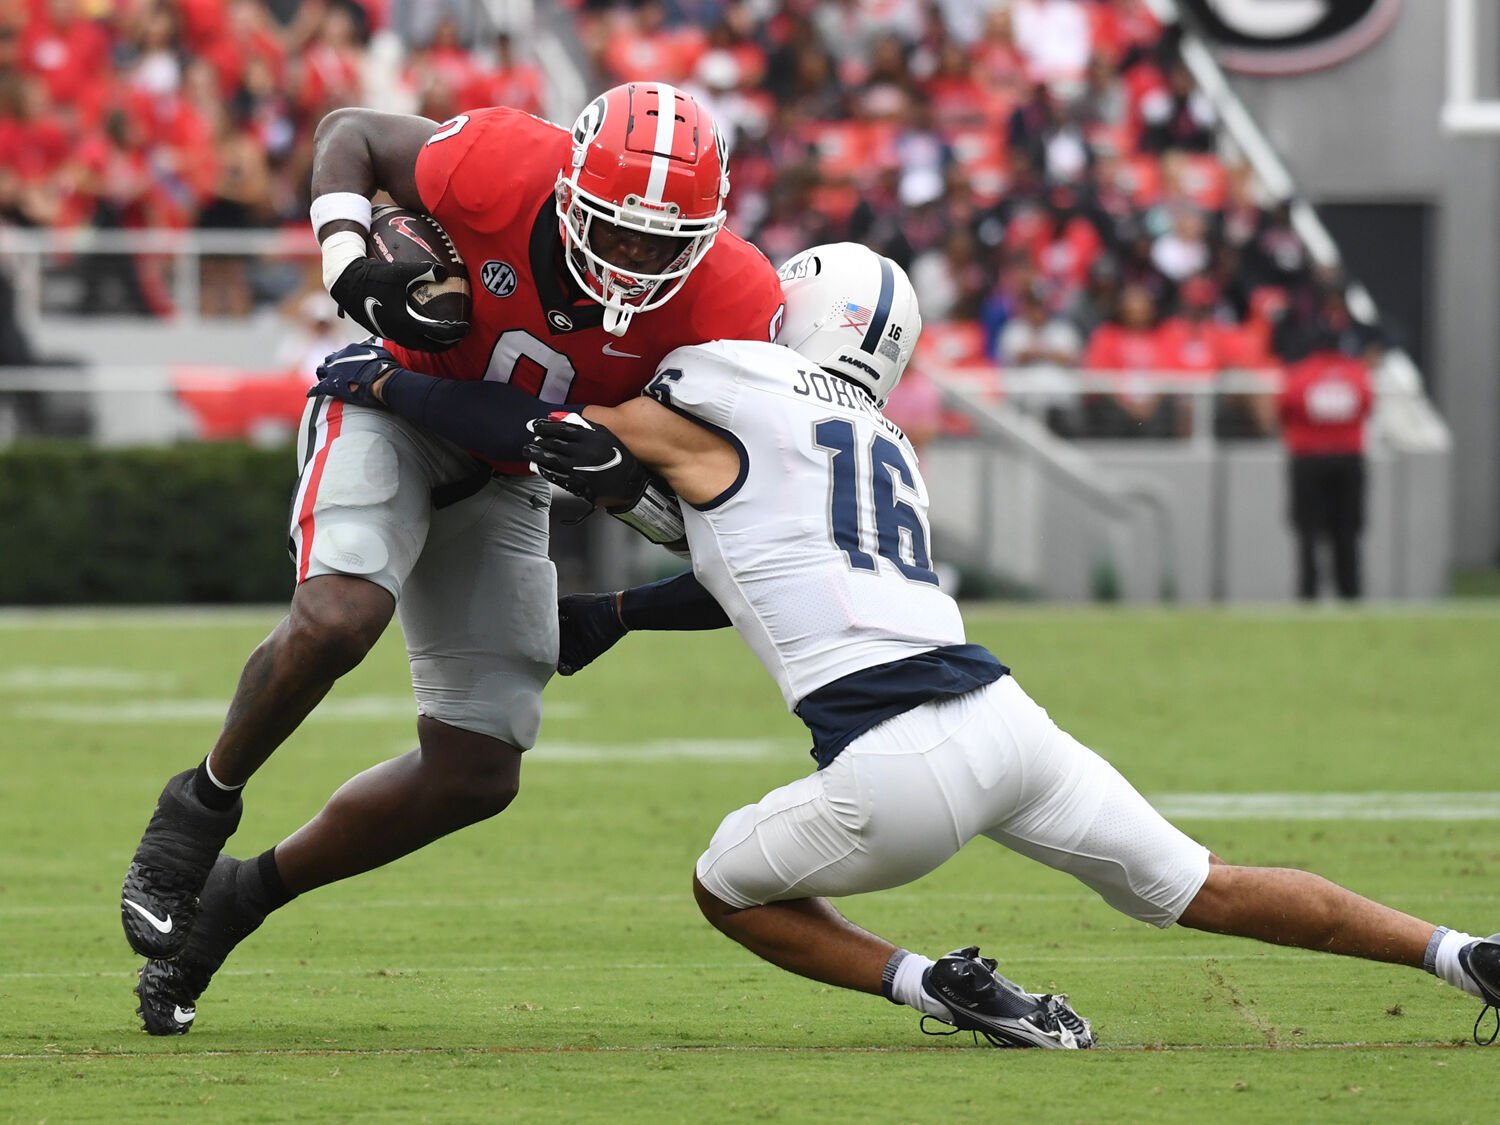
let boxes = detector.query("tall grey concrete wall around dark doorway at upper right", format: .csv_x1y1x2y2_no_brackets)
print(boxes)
1232,0,1500,566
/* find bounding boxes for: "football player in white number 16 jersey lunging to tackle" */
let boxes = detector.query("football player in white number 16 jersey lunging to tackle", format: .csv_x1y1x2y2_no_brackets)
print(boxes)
310,243,1500,1049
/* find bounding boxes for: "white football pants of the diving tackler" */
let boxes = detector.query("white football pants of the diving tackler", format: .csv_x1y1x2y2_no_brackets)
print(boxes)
698,677,1209,927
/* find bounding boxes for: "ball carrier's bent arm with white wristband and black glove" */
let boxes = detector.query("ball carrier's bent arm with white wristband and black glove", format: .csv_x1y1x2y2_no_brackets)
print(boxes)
309,108,468,351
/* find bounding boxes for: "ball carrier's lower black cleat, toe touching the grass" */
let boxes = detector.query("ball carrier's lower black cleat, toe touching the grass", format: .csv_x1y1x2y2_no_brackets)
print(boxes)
135,855,267,1035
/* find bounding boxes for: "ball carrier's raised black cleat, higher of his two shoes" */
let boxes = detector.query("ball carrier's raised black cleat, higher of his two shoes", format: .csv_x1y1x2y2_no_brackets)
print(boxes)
120,770,245,959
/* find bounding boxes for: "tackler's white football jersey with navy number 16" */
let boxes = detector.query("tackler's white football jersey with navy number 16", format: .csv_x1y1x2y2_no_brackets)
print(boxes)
647,341,965,710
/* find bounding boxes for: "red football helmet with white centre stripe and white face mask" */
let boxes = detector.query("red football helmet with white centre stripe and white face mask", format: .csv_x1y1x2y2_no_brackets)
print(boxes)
557,83,729,336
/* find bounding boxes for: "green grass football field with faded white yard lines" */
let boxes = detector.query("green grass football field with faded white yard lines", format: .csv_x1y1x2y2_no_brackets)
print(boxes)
0,600,1500,1125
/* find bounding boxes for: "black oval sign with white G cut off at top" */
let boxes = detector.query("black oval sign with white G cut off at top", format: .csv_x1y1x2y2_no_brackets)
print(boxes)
1178,0,1398,75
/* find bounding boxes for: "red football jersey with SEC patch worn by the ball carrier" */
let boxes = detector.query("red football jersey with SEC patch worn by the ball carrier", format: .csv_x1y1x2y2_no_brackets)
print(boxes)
387,107,782,471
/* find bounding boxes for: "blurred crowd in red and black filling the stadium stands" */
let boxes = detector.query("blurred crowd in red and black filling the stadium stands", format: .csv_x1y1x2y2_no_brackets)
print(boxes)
0,0,1380,437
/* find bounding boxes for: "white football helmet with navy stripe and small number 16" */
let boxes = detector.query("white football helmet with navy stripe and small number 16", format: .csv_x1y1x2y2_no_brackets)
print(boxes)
776,242,923,407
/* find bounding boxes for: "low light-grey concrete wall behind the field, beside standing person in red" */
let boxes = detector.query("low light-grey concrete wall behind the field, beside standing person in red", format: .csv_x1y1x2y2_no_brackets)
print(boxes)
923,440,1451,605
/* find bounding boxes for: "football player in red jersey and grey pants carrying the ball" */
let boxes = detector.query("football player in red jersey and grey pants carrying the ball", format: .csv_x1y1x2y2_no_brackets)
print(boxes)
120,83,782,1035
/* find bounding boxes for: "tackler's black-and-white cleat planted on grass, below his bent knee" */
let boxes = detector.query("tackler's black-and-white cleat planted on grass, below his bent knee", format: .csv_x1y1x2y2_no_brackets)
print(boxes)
923,945,1094,1050
